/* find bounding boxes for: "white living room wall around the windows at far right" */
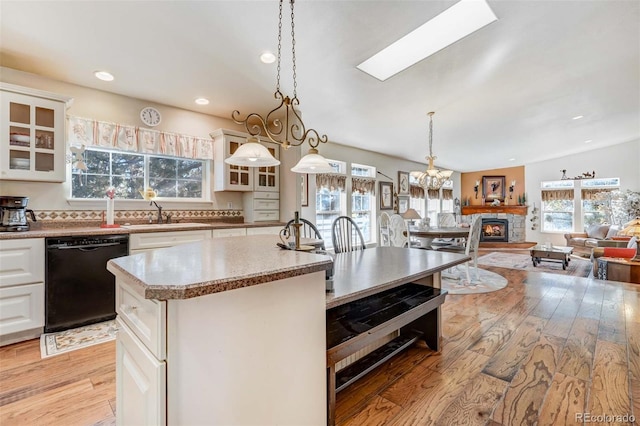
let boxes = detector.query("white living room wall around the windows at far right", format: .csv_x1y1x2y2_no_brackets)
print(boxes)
525,140,640,245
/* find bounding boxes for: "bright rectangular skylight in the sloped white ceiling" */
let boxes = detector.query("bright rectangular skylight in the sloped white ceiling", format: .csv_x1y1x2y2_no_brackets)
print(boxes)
357,0,498,81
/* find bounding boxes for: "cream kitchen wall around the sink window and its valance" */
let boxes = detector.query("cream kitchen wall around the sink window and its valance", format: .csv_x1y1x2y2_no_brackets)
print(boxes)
0,67,242,210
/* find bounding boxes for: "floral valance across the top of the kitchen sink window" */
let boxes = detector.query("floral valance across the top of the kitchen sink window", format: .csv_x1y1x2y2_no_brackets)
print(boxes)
67,115,213,160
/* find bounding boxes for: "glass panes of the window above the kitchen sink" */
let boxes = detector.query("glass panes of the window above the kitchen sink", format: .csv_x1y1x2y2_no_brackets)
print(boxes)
71,148,205,200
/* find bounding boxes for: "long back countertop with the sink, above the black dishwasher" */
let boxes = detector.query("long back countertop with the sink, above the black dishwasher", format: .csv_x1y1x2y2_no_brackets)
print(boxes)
0,222,286,240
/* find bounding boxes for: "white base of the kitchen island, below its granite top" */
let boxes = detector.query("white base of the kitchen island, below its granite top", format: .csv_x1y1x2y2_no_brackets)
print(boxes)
116,271,326,425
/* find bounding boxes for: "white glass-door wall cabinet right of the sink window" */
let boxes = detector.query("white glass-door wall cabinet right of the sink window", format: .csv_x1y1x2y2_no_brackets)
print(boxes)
211,129,280,191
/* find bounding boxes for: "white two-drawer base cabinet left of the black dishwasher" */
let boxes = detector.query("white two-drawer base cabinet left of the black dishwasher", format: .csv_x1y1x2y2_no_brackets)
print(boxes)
0,238,44,345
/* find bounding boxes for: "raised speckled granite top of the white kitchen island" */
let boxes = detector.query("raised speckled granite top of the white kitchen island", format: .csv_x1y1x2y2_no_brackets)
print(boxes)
107,235,331,300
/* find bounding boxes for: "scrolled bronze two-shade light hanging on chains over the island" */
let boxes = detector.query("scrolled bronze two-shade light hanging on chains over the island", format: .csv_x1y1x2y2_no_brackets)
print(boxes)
225,0,334,173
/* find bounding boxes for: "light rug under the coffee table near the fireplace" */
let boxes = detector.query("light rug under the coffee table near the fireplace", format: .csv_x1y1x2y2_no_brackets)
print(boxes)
478,252,592,277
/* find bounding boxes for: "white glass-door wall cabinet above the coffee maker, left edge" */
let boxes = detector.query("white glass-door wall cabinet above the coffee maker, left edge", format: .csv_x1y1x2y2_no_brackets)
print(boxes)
0,83,72,182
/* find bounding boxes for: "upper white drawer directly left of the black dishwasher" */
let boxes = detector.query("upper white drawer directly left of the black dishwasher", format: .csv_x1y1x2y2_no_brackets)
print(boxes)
0,238,44,287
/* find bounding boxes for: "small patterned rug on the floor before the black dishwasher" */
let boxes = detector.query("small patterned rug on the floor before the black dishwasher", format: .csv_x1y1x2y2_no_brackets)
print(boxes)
40,320,116,358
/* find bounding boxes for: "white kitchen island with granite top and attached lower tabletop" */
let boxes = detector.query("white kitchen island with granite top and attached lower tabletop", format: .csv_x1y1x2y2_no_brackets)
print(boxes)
108,235,466,425
